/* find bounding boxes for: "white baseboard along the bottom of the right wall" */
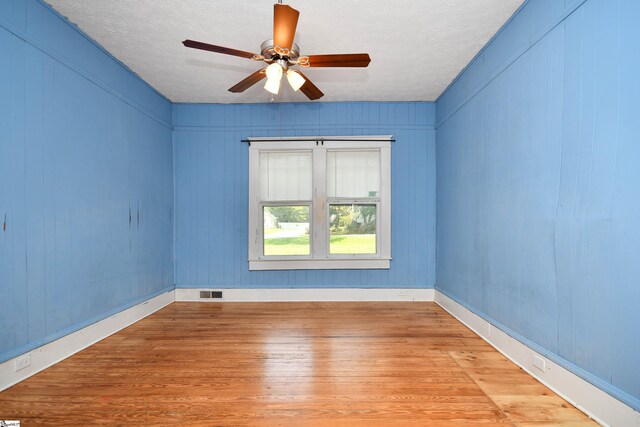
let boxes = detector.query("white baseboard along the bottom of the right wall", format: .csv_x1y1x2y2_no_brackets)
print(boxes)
435,291,640,427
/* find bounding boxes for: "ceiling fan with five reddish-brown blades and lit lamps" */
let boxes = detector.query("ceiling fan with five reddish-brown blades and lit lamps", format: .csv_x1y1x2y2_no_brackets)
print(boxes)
182,0,371,100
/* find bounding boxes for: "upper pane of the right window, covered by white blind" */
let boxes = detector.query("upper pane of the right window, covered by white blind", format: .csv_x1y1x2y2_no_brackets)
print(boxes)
327,150,380,197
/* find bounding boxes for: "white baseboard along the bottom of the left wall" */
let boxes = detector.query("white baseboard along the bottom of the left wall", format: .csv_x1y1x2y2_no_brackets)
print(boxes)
0,291,174,391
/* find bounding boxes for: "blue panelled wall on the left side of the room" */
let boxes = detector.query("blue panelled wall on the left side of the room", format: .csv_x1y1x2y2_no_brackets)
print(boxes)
0,0,173,361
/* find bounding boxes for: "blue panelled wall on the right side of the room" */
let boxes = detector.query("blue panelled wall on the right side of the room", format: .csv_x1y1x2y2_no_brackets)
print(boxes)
437,0,640,409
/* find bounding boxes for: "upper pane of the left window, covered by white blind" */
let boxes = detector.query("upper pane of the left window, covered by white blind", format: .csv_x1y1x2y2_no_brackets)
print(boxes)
260,151,312,201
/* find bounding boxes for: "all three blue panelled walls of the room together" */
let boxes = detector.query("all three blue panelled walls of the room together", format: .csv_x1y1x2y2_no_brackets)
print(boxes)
0,0,640,409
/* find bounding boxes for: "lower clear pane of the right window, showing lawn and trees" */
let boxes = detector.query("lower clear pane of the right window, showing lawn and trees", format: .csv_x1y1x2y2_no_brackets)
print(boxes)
329,205,376,254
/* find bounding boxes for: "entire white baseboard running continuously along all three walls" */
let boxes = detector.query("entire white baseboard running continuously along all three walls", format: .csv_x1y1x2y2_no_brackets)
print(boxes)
6,288,640,427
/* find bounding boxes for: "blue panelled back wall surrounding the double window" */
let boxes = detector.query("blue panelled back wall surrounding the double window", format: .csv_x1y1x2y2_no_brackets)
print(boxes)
173,102,435,288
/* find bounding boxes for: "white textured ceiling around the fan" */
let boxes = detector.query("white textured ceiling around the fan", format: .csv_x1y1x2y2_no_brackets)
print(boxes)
46,0,523,103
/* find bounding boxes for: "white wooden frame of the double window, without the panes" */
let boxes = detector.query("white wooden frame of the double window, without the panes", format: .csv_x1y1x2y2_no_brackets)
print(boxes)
248,135,392,270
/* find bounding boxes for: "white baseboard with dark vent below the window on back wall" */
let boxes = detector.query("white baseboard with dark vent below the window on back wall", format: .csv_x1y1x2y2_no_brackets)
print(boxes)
175,288,434,302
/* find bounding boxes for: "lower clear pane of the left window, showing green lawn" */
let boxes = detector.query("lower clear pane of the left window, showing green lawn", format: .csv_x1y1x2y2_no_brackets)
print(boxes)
263,206,311,255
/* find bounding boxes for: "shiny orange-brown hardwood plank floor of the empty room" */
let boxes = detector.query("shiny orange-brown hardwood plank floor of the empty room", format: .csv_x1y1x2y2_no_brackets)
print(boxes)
0,302,595,426
